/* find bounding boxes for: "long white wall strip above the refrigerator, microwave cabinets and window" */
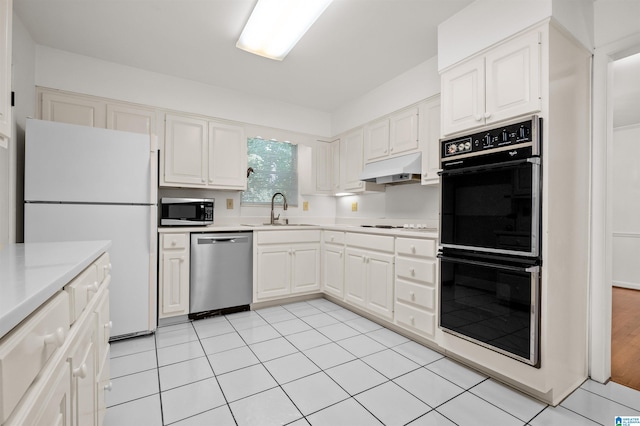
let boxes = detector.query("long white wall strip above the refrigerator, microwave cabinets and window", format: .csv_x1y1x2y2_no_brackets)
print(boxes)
36,45,331,136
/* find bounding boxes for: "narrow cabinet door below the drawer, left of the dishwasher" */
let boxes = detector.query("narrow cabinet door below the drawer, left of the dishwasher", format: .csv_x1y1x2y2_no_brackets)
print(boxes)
158,250,189,318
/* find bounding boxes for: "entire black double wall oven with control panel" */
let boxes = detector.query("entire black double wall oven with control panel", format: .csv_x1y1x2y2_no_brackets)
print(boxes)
438,116,542,366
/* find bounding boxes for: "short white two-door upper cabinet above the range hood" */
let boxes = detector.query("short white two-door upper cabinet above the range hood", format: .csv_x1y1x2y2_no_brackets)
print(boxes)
364,107,419,163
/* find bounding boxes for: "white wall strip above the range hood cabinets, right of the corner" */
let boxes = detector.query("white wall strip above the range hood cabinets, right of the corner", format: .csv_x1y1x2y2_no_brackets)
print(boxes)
331,56,440,136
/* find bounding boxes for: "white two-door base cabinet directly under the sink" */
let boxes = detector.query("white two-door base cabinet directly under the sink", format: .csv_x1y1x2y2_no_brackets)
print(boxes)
254,230,320,301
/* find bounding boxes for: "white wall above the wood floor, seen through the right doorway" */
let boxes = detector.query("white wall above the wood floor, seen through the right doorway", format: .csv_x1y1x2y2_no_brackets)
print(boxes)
611,125,640,290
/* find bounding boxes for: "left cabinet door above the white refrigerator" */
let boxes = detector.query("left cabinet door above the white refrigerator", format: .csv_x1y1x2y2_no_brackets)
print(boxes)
41,91,106,129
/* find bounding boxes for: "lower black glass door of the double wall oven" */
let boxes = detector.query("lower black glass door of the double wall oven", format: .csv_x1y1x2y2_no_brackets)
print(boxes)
439,254,540,367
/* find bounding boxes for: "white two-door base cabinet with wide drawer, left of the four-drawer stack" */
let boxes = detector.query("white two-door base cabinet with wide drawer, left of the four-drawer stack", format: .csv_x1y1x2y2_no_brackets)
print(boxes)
344,232,394,319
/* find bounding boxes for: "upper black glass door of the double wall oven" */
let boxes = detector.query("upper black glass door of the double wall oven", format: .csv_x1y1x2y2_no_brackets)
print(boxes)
440,157,540,257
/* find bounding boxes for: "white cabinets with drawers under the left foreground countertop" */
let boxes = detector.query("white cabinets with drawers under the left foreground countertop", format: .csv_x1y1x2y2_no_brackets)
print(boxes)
0,250,111,426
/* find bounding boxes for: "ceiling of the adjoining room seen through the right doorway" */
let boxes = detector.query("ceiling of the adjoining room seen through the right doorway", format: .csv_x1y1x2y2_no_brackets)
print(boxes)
613,53,640,128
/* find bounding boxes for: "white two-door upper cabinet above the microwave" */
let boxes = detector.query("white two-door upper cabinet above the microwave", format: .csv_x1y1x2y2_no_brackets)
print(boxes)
160,114,247,190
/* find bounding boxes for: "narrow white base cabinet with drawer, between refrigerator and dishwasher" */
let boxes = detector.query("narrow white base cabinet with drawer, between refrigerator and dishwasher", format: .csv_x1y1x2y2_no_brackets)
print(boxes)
158,232,190,319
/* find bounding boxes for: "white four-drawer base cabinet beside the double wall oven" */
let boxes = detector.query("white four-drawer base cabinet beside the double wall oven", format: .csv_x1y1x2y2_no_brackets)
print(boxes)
394,238,437,338
